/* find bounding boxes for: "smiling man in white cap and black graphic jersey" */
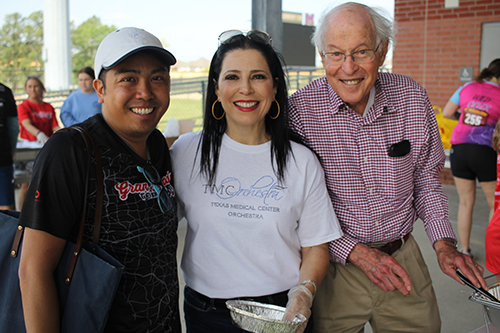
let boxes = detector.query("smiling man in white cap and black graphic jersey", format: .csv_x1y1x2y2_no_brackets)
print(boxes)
19,28,181,332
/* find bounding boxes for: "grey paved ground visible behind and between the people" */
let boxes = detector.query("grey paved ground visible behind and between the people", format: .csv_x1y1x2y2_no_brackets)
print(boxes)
15,185,500,333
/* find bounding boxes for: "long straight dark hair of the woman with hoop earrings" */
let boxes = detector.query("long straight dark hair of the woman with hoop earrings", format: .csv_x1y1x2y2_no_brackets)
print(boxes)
198,36,300,185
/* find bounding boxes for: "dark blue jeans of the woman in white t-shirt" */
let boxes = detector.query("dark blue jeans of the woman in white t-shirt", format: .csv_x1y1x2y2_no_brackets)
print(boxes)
184,286,312,333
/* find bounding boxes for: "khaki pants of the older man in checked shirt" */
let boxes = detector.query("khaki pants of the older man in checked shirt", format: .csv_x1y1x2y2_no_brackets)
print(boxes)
313,236,441,333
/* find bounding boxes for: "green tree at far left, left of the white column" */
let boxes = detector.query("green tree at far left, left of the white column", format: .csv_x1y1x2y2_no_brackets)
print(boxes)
0,11,43,92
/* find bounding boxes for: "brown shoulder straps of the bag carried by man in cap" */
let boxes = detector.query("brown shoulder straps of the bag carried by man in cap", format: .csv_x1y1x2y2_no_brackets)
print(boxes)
64,126,104,284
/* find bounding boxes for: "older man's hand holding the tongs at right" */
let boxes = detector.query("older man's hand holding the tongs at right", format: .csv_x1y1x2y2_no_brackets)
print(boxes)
434,239,488,288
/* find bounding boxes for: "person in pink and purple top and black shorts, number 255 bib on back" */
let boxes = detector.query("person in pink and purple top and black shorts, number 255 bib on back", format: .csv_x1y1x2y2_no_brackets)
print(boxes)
443,59,500,255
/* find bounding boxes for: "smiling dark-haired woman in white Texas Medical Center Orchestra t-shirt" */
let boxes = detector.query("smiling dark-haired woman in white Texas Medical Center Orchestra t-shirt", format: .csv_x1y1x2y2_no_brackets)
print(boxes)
171,30,342,333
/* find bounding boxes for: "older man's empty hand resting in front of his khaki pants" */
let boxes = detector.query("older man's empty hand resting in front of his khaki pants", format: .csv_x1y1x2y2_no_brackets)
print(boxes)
348,243,412,296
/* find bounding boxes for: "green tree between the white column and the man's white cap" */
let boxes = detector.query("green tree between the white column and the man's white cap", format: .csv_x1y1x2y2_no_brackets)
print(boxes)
71,16,117,80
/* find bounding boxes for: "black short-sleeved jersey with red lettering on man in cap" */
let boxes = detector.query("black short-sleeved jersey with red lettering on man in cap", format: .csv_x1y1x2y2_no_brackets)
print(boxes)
20,114,184,332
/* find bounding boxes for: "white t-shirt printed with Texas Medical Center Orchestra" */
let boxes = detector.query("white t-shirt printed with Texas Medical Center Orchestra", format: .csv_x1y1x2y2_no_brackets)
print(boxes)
171,132,342,298
